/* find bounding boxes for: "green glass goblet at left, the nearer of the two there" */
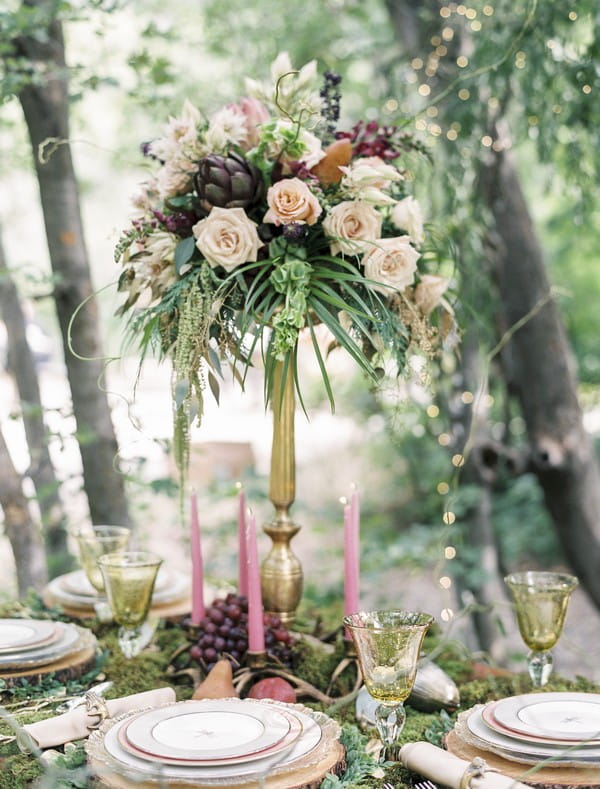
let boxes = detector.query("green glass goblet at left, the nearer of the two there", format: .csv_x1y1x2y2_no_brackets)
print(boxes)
98,551,163,658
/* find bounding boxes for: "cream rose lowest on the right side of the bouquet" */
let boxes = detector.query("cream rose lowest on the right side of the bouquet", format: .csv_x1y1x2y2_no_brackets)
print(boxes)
362,236,420,295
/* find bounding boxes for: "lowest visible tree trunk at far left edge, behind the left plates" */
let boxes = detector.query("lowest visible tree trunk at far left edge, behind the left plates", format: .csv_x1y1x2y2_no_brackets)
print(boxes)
0,422,48,597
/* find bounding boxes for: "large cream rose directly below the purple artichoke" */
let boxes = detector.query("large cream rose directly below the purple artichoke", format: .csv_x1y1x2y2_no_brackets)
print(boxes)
192,207,263,272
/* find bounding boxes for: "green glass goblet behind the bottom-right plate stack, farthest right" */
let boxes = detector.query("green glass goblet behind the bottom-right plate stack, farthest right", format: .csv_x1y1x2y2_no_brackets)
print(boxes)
504,570,579,688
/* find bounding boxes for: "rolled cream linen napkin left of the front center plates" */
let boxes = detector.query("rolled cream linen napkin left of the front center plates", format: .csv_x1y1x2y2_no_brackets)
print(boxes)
23,688,175,750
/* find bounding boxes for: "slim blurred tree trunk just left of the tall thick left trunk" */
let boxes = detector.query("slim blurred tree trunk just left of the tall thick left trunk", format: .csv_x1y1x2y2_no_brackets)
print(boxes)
0,225,72,577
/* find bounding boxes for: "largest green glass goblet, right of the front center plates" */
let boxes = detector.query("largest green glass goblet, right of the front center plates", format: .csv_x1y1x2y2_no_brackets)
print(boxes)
344,611,433,761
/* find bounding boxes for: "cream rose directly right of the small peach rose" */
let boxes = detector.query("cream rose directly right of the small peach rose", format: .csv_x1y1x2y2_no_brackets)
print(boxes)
323,200,382,255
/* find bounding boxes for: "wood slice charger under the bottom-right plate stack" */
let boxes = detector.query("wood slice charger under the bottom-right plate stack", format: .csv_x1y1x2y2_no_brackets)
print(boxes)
444,731,600,789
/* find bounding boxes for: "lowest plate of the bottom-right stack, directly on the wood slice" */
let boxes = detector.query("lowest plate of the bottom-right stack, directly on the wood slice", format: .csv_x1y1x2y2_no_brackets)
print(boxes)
464,706,600,767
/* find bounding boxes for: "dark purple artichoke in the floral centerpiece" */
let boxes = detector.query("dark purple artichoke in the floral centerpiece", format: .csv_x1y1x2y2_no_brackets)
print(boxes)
194,153,264,211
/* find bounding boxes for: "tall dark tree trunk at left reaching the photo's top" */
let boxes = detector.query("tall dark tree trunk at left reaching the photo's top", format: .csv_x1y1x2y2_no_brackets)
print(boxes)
17,0,130,525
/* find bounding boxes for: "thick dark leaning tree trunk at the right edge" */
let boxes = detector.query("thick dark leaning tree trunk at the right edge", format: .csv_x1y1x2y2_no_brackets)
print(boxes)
482,145,600,608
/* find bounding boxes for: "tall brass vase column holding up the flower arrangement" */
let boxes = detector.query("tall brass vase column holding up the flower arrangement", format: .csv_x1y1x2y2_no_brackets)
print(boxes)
261,362,303,625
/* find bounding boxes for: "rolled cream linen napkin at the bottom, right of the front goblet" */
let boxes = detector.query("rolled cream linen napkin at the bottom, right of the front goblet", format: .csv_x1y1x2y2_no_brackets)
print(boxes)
400,742,530,789
